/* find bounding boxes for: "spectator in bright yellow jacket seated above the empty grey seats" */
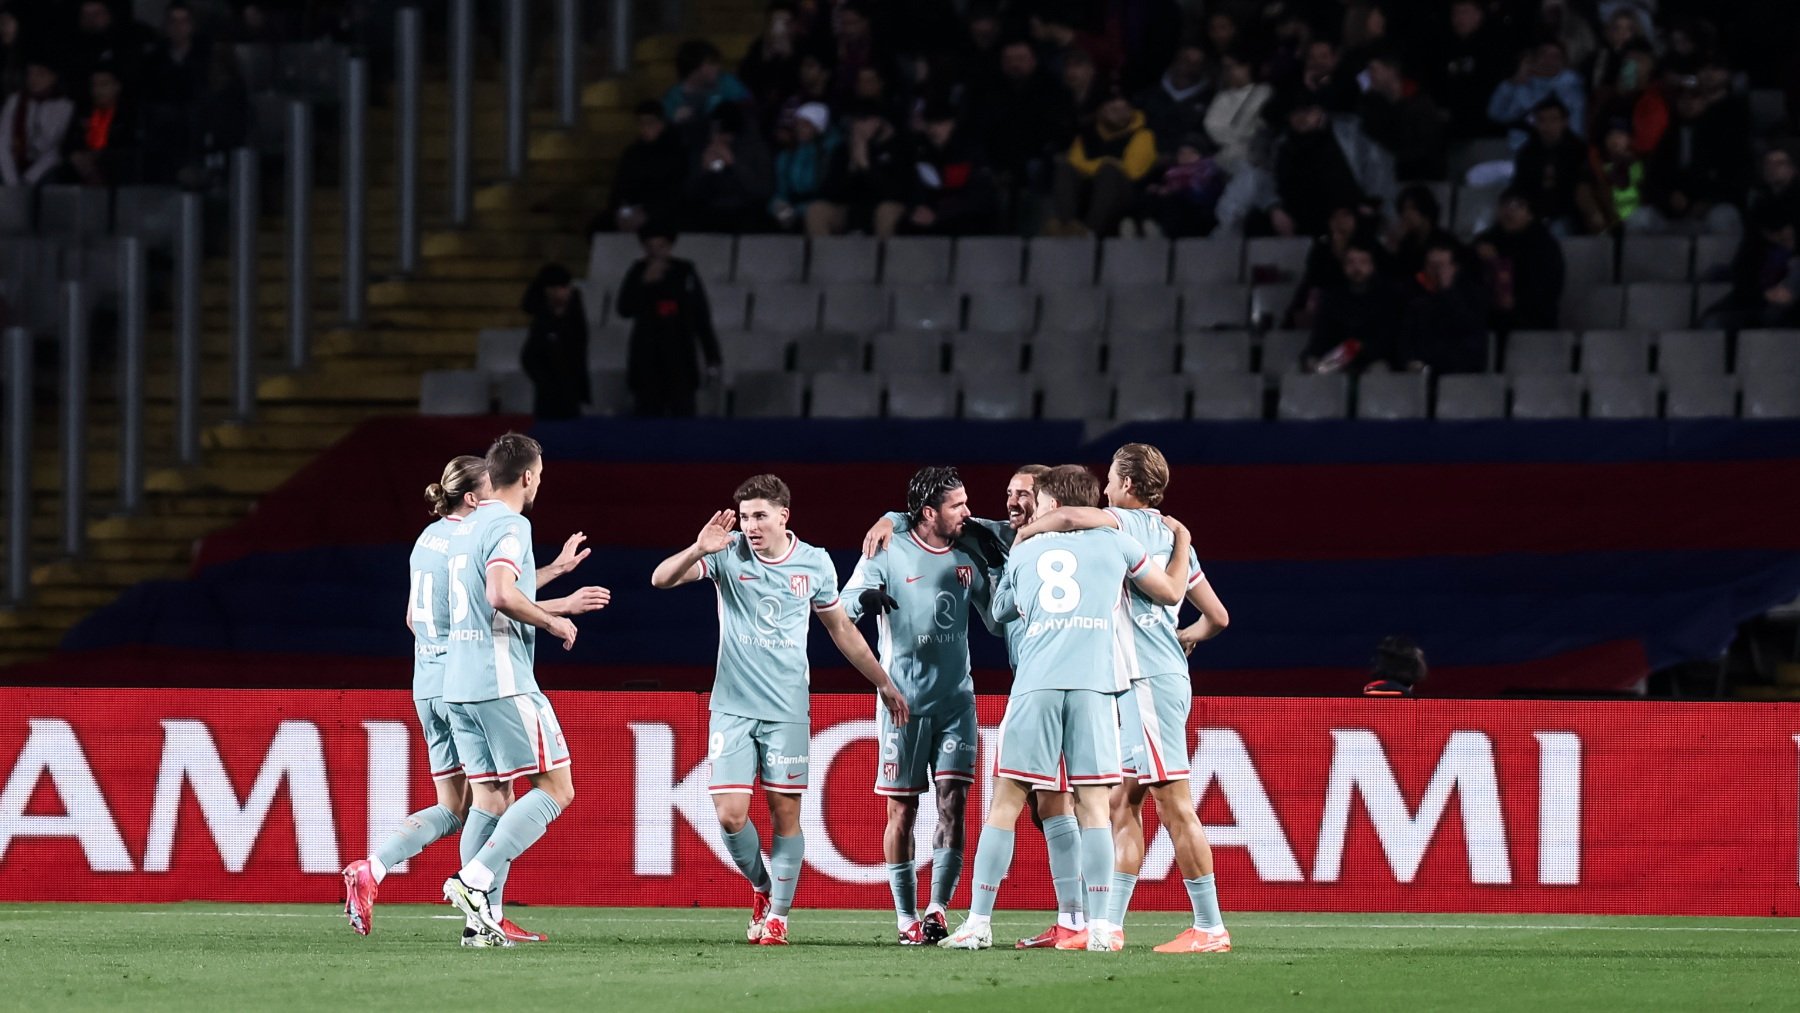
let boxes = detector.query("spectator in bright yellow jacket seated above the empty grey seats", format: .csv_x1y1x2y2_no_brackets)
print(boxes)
1046,92,1156,236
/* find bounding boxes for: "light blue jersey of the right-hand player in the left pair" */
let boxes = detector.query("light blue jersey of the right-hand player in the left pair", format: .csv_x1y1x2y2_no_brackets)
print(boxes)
445,500,538,704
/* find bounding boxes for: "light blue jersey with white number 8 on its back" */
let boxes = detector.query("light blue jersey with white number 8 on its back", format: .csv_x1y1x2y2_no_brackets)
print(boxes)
994,527,1150,696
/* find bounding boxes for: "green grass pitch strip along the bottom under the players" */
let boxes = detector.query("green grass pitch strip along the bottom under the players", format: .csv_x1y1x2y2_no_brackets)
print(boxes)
0,903,1800,1013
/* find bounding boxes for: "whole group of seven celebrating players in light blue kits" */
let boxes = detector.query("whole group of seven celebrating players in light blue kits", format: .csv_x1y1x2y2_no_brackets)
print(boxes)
344,434,1231,954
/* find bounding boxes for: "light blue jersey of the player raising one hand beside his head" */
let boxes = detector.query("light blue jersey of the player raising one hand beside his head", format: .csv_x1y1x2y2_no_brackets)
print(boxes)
700,531,839,722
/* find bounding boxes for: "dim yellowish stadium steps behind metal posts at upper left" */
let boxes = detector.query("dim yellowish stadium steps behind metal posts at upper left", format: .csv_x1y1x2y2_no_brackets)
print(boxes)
0,19,760,666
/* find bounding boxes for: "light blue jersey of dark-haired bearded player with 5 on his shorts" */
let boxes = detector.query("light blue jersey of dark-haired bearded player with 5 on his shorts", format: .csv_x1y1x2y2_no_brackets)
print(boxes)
844,533,985,716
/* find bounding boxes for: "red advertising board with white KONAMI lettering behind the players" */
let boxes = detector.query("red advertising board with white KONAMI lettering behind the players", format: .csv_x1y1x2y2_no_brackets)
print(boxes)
0,689,1800,916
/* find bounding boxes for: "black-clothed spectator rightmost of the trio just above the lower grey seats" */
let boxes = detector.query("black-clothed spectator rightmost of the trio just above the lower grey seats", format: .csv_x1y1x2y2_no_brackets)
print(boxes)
1474,189,1564,333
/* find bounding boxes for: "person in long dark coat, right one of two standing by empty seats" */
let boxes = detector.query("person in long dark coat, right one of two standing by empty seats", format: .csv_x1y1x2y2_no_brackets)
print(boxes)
616,225,720,417
